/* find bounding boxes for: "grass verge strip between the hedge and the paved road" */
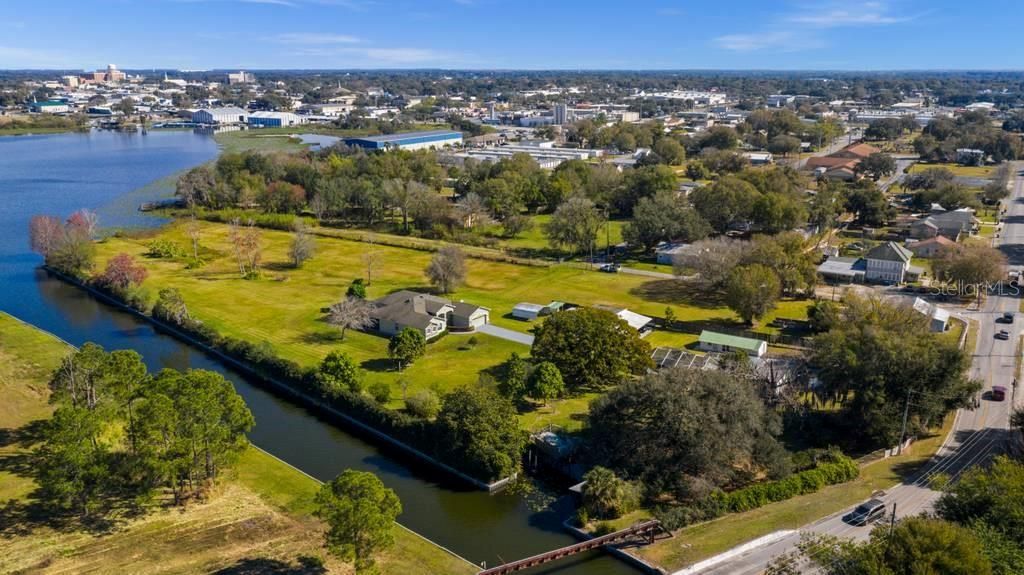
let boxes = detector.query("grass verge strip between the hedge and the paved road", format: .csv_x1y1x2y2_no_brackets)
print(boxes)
614,414,953,572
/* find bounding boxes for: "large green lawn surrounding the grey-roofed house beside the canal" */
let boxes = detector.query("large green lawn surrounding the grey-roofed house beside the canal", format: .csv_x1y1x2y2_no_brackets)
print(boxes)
98,218,807,425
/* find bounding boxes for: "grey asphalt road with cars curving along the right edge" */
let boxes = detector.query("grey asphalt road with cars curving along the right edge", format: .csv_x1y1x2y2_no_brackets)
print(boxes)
700,163,1024,575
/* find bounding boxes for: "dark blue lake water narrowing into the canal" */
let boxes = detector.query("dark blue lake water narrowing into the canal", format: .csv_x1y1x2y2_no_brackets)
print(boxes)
0,132,636,575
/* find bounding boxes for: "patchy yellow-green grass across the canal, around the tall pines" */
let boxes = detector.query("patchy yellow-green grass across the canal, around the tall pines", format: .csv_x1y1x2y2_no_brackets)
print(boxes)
0,313,476,575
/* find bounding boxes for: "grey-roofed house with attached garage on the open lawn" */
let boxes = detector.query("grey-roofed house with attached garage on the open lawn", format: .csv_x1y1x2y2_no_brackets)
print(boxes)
370,290,490,340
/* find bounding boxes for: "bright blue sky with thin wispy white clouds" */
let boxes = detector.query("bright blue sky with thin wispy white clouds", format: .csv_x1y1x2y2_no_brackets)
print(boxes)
0,0,1024,70
